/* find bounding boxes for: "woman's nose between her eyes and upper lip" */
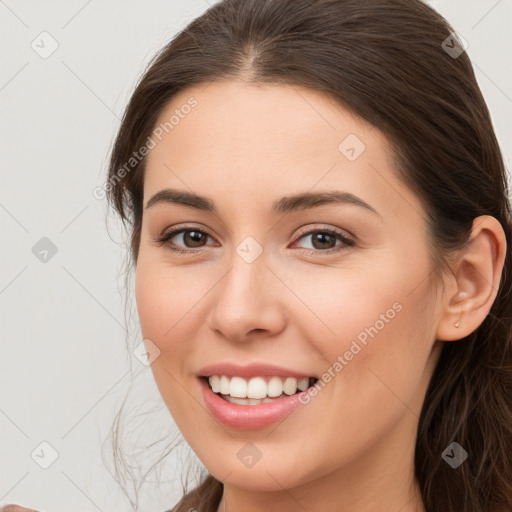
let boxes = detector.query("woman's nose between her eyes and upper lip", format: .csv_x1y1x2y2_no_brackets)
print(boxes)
210,249,286,342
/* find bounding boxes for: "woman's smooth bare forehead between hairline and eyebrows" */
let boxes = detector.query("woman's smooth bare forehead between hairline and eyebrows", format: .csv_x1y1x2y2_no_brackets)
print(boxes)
144,82,421,221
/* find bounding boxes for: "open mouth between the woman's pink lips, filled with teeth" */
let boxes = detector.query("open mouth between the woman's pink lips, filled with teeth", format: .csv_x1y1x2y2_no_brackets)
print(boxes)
199,375,318,406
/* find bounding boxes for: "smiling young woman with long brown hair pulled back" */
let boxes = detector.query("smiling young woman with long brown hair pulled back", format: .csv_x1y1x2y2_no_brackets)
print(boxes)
6,0,512,512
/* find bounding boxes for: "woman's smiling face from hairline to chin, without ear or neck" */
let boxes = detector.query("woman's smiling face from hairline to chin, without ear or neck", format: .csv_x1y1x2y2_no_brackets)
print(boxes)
136,82,440,490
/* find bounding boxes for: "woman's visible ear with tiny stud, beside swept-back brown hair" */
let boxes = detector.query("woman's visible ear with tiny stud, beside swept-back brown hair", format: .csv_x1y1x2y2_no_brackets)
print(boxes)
436,215,507,341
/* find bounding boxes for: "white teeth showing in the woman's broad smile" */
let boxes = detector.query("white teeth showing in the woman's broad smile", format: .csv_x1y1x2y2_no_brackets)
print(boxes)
208,375,316,398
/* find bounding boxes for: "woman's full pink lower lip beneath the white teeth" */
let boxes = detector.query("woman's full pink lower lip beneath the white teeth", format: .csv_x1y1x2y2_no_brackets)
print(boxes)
198,378,308,430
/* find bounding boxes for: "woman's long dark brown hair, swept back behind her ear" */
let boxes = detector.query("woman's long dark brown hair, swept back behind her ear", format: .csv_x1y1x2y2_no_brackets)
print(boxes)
107,0,512,512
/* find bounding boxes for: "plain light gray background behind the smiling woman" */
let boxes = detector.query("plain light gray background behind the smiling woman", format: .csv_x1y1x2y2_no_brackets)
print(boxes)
0,0,512,512
